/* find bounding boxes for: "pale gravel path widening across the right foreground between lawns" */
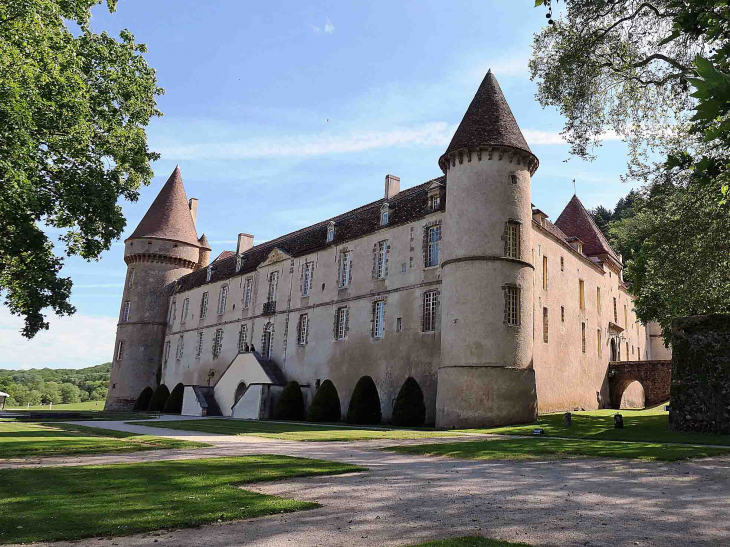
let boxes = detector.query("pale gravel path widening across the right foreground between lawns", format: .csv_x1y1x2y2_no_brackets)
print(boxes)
5,418,730,547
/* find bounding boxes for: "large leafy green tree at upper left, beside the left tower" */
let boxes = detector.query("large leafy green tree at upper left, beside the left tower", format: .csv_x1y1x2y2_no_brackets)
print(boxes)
0,0,163,338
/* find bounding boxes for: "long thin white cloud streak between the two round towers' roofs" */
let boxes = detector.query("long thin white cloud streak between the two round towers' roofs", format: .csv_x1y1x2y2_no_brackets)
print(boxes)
161,122,456,160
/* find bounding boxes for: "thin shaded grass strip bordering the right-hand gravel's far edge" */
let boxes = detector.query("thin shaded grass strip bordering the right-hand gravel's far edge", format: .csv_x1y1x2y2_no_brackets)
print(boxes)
385,437,730,462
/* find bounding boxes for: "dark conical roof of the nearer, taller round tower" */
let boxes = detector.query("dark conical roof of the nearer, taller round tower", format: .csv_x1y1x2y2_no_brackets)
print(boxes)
441,70,537,169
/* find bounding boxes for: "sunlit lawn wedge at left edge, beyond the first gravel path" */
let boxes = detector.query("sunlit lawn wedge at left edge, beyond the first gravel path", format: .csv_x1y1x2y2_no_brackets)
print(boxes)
0,422,210,459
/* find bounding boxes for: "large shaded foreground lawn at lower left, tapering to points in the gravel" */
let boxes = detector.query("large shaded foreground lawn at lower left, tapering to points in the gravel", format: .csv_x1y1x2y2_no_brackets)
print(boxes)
0,455,363,544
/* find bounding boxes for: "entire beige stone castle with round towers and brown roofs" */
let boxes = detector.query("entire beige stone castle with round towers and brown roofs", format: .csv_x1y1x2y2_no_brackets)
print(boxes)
106,72,666,427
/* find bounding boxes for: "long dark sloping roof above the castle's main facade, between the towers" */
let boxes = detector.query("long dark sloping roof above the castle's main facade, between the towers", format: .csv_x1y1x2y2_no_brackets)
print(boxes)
173,176,446,292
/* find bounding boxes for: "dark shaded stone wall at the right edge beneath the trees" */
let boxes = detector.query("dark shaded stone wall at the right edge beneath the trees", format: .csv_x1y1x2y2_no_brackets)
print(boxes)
669,314,730,433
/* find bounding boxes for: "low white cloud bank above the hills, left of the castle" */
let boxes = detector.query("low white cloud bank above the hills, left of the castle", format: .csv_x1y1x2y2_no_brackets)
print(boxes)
0,306,117,369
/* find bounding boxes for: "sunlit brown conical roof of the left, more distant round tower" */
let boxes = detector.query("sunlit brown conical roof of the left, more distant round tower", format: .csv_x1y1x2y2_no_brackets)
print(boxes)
127,167,199,247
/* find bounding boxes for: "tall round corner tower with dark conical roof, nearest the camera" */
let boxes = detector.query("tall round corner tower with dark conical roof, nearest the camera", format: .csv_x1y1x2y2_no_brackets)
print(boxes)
436,71,538,428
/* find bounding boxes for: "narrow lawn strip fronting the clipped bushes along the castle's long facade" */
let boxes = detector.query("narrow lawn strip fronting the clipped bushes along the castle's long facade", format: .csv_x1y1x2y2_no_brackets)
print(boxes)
128,419,459,442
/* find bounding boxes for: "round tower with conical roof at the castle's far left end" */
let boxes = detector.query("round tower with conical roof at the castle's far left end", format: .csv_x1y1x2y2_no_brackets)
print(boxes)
105,167,201,410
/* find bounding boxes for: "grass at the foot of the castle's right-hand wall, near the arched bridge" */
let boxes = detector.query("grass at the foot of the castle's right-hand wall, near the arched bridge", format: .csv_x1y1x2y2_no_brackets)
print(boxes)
463,405,730,446
